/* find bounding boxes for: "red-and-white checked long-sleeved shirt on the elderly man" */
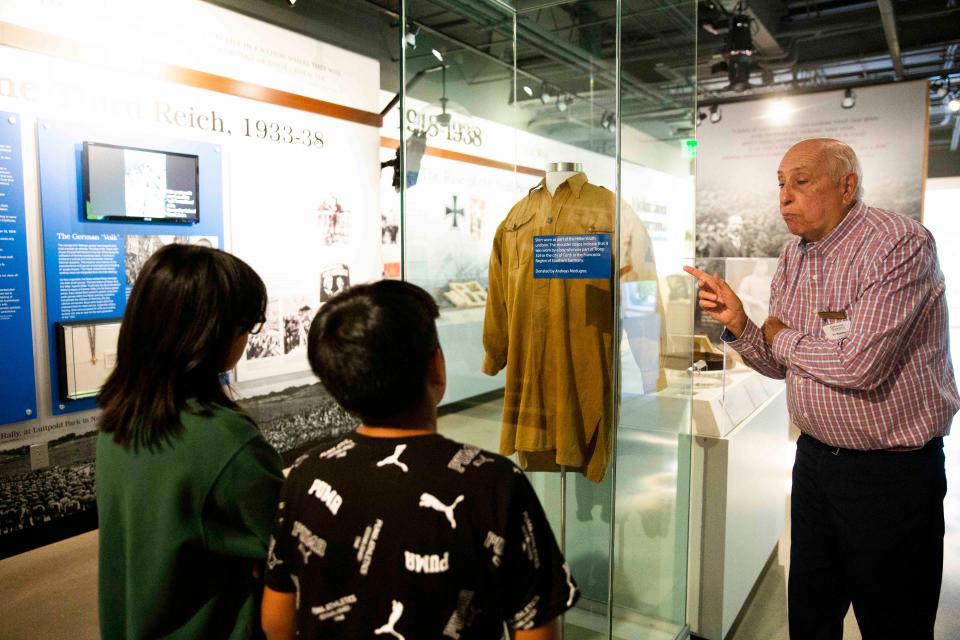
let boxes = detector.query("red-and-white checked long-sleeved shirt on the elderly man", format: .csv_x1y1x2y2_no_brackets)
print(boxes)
724,202,960,450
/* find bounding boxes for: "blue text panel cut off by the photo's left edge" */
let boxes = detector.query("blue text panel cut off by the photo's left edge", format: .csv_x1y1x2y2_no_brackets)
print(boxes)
0,111,37,424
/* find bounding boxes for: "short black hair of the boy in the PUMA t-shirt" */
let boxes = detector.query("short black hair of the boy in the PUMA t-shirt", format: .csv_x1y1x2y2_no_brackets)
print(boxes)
307,280,440,426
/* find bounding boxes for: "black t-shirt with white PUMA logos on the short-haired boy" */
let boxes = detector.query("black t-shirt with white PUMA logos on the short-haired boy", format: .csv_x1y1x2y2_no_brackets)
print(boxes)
266,432,580,640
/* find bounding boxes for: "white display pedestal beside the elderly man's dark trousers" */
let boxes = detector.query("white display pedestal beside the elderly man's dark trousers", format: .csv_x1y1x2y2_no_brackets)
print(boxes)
687,382,790,640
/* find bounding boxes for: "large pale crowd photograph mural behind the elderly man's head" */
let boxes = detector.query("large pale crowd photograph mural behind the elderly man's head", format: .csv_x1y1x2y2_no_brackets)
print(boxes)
696,82,927,258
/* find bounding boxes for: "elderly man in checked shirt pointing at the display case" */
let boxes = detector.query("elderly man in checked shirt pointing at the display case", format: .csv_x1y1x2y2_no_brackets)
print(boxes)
686,139,960,640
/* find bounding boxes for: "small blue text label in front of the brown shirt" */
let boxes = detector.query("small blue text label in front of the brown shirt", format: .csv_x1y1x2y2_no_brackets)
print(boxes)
533,233,613,280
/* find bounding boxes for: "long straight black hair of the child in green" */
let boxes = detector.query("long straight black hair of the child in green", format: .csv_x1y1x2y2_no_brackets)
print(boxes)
97,244,267,449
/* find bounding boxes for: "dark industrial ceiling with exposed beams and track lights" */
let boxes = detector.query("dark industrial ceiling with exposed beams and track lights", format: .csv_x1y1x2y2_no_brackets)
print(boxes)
216,0,960,175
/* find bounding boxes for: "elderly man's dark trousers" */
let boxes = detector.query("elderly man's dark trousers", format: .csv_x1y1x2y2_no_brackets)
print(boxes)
788,435,947,640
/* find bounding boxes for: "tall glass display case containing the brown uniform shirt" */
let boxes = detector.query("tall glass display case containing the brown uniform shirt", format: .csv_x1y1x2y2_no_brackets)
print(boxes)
398,0,696,639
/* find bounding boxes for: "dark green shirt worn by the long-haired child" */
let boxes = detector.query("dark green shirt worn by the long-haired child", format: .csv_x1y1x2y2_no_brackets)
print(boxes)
97,408,283,640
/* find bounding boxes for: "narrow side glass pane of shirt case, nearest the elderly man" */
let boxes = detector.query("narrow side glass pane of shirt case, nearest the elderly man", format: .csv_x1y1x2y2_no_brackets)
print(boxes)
613,0,697,638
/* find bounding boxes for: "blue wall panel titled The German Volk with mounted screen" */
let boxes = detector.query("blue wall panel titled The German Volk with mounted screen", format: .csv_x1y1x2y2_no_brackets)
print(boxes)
37,122,223,415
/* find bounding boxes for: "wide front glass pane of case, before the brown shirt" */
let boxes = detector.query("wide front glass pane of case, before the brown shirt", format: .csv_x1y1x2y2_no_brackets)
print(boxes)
403,0,617,638
